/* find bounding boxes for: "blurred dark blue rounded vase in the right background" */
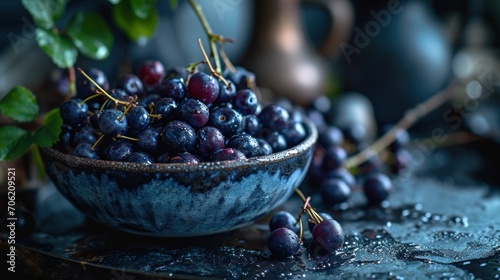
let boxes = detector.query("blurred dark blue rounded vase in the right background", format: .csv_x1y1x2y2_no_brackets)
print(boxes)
341,0,452,124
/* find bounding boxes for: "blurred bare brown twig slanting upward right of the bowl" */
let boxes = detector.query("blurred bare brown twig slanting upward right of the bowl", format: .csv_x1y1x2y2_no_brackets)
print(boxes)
344,75,472,169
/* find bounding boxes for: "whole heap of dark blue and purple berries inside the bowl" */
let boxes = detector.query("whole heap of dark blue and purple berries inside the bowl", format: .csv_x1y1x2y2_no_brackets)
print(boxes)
58,61,307,164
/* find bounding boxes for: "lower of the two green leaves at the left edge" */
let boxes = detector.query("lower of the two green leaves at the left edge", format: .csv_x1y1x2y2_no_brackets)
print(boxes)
0,125,33,160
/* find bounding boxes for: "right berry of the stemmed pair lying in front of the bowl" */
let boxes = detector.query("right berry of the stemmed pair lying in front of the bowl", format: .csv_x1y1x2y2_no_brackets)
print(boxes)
312,219,345,254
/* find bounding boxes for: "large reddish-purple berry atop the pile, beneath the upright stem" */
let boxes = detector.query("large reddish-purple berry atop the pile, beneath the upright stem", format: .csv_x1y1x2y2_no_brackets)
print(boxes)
187,72,219,104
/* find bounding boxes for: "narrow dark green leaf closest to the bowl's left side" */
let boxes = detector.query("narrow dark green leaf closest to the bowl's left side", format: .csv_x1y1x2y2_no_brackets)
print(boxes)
33,108,63,147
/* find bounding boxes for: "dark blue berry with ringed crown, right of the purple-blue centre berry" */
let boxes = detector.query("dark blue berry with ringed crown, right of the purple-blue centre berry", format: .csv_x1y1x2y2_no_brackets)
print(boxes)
208,107,243,138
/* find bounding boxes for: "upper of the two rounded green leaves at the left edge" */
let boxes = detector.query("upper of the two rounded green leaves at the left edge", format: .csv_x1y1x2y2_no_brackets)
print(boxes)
0,86,39,122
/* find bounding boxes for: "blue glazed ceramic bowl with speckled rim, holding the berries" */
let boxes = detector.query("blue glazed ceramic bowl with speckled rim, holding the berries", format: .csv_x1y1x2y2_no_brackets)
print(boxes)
41,121,317,237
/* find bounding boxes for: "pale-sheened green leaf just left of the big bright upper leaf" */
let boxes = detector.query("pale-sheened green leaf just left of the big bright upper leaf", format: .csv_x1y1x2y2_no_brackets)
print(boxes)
36,28,78,68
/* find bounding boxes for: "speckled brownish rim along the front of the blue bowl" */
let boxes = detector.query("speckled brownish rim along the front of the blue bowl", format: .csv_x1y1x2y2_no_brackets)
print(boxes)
40,116,318,173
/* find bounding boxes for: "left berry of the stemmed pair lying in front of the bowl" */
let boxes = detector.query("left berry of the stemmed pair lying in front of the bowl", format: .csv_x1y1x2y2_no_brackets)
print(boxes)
267,227,300,259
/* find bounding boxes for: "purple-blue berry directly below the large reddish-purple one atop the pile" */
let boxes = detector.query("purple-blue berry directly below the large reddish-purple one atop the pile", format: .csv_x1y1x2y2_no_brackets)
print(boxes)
176,98,210,129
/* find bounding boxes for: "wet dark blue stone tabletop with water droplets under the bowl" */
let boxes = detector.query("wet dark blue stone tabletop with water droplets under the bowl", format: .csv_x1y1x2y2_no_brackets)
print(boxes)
0,143,500,279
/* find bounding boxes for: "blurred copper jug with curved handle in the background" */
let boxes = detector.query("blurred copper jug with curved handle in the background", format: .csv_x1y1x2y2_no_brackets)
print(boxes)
241,0,353,105
